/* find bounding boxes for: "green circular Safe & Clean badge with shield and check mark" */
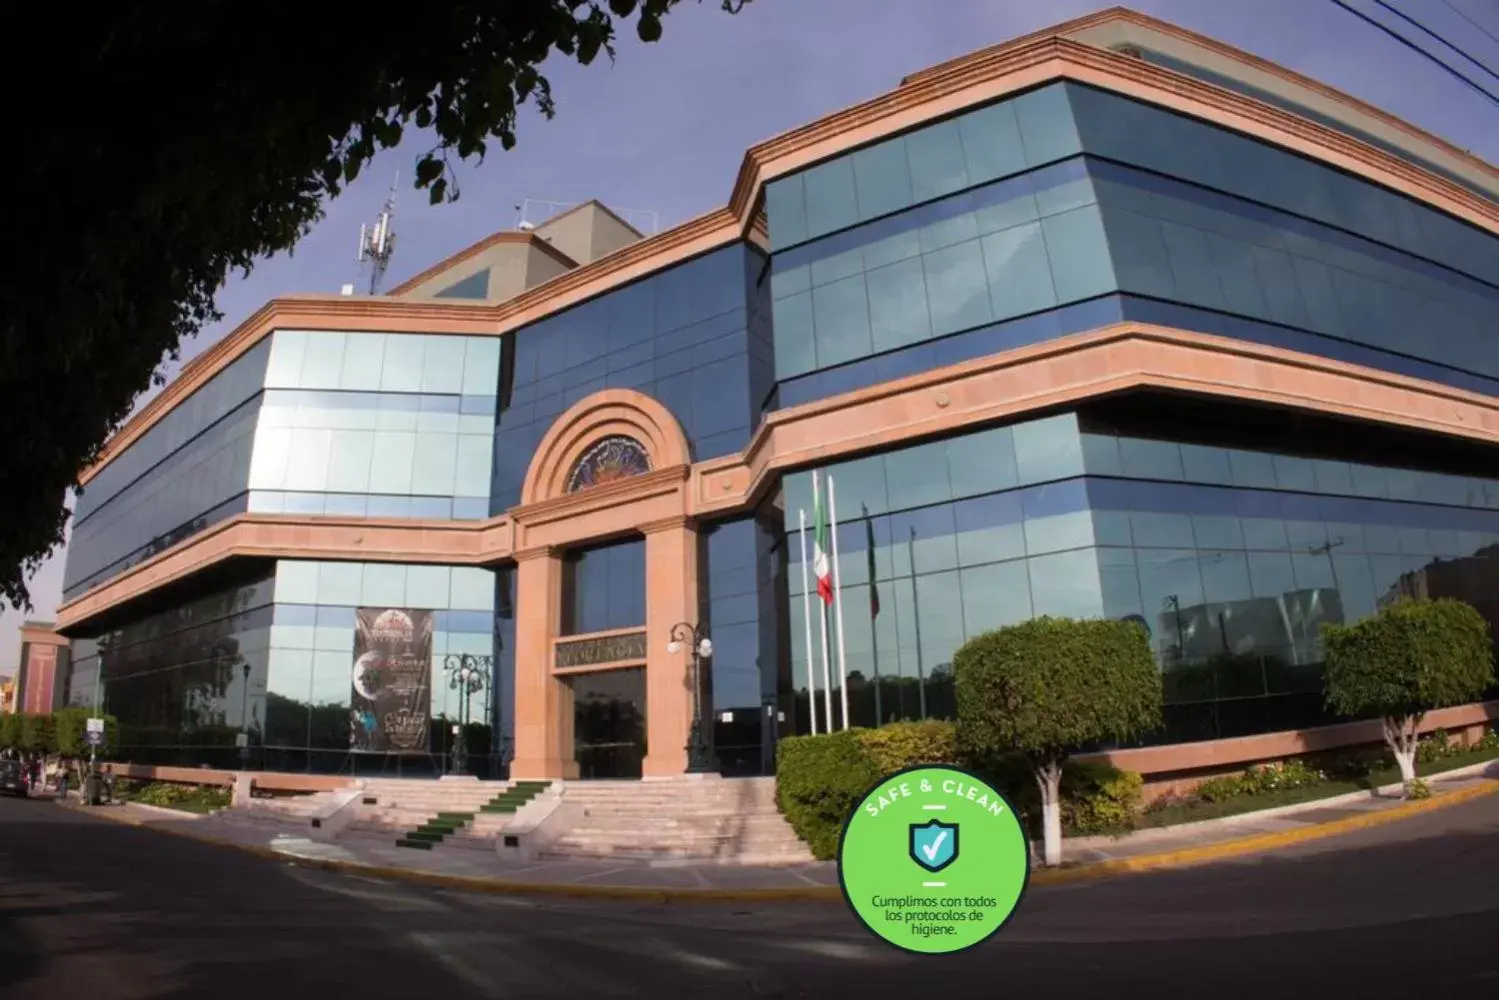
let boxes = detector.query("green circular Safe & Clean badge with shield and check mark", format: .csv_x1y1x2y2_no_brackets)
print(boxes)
838,766,1030,955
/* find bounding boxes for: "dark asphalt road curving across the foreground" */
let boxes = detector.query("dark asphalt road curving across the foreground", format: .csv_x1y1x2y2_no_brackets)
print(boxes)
0,796,1499,1000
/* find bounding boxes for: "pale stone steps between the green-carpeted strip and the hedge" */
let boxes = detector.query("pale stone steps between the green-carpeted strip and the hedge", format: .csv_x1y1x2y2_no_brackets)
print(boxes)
541,775,812,865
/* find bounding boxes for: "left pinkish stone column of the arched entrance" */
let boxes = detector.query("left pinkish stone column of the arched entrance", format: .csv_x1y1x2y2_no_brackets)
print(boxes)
510,549,577,780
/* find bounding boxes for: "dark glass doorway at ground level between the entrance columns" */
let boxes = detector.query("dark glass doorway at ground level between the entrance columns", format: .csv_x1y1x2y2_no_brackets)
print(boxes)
568,667,646,778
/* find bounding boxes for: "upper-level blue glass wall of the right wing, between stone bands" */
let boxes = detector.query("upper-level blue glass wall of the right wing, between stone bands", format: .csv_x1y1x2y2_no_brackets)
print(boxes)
766,84,1499,406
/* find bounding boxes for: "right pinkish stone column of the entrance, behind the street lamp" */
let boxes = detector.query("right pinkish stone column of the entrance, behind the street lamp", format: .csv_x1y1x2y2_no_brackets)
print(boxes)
643,517,695,778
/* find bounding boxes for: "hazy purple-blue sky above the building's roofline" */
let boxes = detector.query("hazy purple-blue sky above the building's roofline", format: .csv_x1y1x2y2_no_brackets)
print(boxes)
0,0,1499,673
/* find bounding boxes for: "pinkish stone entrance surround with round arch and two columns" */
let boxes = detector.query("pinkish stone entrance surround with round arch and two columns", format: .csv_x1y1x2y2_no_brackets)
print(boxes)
510,390,697,778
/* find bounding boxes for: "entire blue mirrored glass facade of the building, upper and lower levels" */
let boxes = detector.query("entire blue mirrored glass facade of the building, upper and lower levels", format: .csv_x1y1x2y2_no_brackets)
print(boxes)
64,43,1499,777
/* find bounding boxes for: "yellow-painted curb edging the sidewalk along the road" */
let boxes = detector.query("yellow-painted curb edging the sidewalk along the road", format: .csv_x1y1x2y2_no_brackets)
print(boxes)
60,781,1499,904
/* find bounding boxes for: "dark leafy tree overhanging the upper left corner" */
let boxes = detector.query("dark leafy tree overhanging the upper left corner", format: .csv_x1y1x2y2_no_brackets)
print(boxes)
0,0,748,607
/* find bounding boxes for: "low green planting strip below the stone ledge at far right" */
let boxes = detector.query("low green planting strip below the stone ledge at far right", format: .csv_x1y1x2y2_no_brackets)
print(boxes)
1136,745,1499,829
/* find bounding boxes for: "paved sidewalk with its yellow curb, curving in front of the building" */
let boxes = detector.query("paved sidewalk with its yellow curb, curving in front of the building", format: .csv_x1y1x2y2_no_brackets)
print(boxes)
52,763,1499,901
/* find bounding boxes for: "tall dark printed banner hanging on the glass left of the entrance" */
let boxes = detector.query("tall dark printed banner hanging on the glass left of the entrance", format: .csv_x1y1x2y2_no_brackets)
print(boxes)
349,607,432,754
